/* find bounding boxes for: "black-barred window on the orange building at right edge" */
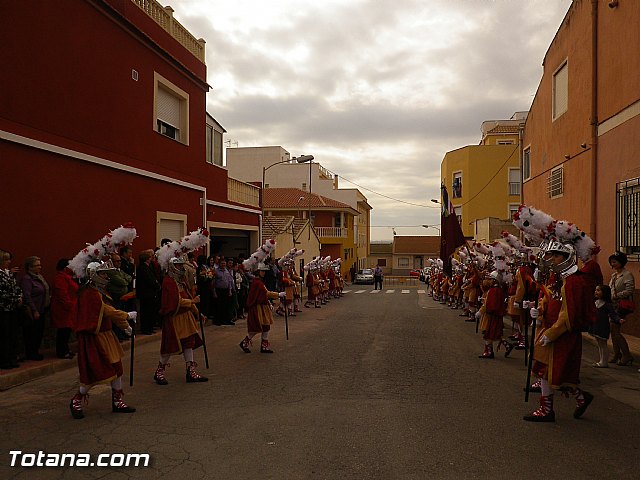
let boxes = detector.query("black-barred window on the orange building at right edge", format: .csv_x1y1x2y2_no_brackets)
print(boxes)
616,178,640,261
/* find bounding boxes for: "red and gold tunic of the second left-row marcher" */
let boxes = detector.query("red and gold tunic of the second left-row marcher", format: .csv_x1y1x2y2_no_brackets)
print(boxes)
160,275,202,355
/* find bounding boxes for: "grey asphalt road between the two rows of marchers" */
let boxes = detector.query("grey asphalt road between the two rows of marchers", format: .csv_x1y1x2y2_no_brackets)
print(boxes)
0,286,640,480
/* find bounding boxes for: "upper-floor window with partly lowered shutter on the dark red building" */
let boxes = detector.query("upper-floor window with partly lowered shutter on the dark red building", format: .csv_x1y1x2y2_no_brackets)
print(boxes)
153,73,189,145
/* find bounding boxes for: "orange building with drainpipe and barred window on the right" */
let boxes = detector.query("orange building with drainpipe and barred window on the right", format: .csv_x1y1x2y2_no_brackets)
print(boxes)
522,0,640,334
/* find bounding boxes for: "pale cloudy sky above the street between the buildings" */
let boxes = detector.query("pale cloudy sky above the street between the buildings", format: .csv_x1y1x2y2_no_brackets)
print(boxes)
174,0,571,240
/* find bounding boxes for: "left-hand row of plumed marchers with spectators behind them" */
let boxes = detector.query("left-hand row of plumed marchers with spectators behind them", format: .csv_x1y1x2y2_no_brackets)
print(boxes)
0,225,344,419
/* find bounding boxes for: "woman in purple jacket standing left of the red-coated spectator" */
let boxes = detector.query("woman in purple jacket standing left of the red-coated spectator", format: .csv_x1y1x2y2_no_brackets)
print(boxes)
21,256,51,361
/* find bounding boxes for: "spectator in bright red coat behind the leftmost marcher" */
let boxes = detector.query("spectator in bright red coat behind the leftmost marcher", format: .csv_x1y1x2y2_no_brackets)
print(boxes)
51,258,78,359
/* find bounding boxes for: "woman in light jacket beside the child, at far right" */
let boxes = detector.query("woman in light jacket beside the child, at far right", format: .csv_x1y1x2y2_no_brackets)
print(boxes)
609,252,636,367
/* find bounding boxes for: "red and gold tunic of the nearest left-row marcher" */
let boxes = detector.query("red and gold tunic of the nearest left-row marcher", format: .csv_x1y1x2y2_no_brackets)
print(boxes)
74,286,129,387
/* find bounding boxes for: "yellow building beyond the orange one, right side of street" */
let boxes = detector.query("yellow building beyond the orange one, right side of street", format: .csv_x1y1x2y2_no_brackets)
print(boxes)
440,112,526,238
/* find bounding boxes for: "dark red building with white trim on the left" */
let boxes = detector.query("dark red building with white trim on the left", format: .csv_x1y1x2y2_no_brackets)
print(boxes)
0,0,261,274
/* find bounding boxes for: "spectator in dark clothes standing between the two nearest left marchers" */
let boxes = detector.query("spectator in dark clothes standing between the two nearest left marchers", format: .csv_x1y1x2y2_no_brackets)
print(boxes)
136,249,162,335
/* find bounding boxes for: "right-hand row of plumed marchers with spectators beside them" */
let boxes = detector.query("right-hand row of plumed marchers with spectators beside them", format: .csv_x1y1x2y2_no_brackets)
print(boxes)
427,205,640,422
